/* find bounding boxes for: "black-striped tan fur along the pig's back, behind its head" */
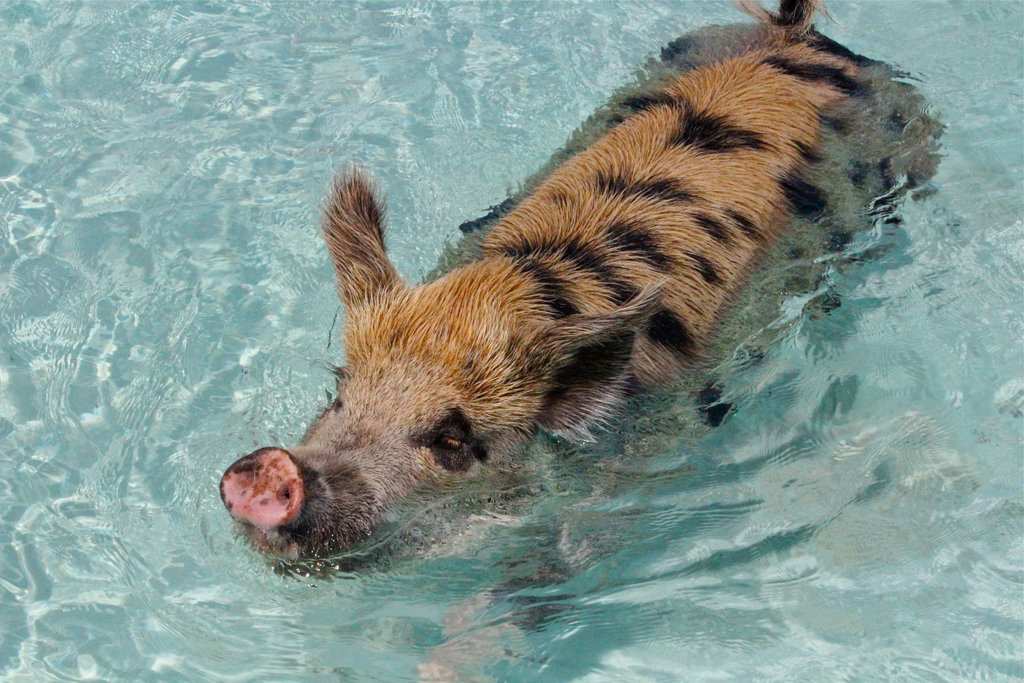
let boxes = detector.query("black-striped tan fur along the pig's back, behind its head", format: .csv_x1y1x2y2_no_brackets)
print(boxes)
473,34,856,383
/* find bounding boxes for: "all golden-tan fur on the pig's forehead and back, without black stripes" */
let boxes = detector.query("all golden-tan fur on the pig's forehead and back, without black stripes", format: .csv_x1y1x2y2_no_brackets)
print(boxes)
326,12,855,444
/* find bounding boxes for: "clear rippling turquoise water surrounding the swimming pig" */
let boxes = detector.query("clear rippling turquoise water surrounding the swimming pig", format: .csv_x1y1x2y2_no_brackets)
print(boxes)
0,0,1024,681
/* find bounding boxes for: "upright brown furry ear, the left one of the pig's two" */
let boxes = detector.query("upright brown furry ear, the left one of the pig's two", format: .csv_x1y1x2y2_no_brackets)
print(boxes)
323,170,401,309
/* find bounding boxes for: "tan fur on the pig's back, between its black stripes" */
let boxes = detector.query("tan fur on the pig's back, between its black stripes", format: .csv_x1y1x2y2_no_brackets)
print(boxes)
471,46,844,382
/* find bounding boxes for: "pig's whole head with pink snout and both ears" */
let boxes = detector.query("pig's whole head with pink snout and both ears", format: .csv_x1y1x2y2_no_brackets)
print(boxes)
220,173,657,558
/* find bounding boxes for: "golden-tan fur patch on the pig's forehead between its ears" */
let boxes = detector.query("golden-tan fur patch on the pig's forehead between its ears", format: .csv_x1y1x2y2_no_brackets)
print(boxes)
345,263,552,446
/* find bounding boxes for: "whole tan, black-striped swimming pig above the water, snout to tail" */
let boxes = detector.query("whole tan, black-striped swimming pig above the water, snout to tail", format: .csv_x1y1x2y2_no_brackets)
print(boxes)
221,0,937,557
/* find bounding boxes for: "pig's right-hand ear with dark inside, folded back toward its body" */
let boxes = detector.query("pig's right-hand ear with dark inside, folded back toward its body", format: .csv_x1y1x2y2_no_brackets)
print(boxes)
537,286,662,439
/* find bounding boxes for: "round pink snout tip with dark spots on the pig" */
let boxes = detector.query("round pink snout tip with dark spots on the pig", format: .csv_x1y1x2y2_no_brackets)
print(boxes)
220,449,305,529
